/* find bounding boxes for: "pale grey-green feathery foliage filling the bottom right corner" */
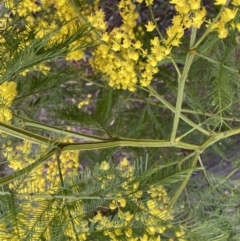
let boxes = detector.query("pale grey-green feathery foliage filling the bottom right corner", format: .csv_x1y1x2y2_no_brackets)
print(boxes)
172,172,239,241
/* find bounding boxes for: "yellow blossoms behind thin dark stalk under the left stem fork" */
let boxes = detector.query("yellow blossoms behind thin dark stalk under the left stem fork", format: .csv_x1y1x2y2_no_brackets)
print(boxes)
7,138,79,193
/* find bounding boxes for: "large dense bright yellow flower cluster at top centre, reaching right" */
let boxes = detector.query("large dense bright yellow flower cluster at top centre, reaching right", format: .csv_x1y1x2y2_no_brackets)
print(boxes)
89,0,240,91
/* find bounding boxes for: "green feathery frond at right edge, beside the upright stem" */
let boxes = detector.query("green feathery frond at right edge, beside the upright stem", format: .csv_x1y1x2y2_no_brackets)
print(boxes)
185,35,239,134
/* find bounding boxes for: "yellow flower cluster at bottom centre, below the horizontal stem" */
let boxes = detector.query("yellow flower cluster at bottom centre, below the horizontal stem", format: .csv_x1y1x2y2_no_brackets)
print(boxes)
89,158,185,241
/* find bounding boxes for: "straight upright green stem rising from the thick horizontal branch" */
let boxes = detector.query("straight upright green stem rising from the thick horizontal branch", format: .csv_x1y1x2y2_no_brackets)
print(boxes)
171,52,194,143
